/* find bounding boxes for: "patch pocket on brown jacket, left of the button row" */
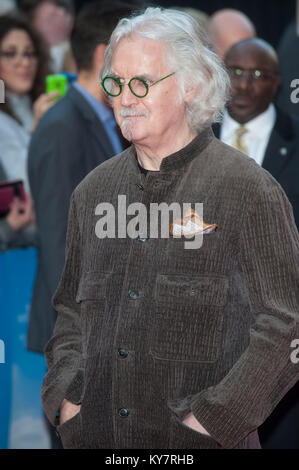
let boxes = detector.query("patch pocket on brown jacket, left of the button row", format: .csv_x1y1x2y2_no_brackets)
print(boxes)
76,271,110,358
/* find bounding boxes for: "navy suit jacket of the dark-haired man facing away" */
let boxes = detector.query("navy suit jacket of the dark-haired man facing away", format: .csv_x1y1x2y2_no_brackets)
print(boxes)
27,87,115,352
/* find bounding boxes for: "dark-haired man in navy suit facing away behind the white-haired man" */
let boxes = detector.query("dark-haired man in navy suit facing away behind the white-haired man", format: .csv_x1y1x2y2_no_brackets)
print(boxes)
27,2,131,352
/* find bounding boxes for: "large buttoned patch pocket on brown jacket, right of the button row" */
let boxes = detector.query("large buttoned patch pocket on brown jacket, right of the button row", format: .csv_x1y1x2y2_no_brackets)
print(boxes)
151,274,228,362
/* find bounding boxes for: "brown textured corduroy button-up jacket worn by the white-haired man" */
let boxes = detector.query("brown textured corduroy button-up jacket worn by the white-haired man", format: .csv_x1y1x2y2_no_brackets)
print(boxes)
42,129,299,449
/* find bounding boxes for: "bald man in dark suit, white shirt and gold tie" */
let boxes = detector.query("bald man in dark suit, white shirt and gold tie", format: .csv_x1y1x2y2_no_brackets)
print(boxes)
214,39,299,448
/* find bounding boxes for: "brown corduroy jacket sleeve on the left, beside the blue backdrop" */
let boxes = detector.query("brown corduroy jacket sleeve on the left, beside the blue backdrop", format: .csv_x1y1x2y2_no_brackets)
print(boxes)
42,192,84,424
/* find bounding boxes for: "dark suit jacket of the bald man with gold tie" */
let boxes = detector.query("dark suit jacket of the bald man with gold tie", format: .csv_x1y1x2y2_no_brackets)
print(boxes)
213,108,299,227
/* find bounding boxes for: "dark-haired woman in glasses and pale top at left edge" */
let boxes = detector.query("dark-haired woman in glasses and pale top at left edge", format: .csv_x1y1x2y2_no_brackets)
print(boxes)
0,15,58,192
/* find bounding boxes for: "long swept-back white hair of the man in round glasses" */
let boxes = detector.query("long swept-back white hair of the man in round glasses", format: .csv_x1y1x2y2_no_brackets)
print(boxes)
101,7,230,131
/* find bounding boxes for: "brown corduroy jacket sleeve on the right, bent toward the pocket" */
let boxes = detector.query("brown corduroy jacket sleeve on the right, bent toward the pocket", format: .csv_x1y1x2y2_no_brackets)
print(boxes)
191,178,299,448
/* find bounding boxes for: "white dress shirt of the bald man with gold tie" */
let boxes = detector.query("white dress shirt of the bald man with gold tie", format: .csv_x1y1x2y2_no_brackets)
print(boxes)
220,103,276,165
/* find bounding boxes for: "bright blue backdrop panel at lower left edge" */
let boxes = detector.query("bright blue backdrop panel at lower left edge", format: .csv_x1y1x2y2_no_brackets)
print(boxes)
0,248,49,449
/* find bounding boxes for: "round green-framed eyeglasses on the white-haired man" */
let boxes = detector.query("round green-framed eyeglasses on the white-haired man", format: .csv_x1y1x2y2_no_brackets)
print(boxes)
101,72,175,98
